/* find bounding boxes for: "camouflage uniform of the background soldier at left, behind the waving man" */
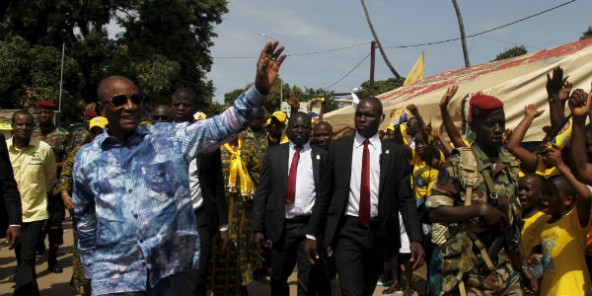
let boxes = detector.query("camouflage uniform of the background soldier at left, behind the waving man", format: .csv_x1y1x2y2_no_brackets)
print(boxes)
38,126,70,265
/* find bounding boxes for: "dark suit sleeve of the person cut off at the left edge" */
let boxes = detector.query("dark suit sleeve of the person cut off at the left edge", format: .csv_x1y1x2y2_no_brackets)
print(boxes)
0,133,22,237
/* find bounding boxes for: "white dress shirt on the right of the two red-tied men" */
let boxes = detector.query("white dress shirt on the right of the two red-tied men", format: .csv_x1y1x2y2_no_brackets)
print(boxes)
345,132,382,217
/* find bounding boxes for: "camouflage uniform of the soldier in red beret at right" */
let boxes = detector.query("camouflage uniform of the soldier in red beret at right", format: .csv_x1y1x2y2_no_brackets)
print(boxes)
426,146,522,295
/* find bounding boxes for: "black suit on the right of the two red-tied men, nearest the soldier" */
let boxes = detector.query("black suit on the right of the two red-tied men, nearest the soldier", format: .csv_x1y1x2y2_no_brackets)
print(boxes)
325,136,421,296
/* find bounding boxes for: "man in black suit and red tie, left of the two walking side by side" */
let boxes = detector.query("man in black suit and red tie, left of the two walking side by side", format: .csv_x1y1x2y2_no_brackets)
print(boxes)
253,112,330,296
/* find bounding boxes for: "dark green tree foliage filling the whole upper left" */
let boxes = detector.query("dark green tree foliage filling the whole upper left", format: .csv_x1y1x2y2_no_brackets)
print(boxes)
0,0,228,123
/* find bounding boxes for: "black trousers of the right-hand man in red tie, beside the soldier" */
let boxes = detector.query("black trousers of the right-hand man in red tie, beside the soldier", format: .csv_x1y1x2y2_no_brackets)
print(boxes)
334,216,384,296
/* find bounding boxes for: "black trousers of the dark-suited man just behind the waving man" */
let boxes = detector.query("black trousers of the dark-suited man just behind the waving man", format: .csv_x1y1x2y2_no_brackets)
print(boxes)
192,206,213,296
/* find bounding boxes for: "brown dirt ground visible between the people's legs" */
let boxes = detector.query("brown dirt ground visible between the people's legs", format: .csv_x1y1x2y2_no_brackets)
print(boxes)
0,216,425,296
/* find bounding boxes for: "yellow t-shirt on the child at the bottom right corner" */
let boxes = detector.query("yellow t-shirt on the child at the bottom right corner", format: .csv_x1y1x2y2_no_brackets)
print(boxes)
540,207,590,295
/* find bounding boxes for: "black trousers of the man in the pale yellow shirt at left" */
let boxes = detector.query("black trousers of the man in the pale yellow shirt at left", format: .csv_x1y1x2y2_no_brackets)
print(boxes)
14,220,45,296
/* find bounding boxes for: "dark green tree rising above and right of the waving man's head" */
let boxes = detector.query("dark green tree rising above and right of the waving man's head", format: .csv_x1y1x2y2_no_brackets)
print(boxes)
119,0,227,109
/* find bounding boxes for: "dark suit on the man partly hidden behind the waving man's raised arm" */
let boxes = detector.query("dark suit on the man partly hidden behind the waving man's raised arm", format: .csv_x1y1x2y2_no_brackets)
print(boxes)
189,149,228,295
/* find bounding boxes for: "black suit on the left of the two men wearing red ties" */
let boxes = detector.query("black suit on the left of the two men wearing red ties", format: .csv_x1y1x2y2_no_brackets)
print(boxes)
253,143,330,295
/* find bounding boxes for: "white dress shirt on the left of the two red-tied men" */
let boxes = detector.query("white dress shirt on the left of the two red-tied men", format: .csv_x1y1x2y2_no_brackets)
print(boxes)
282,141,316,219
